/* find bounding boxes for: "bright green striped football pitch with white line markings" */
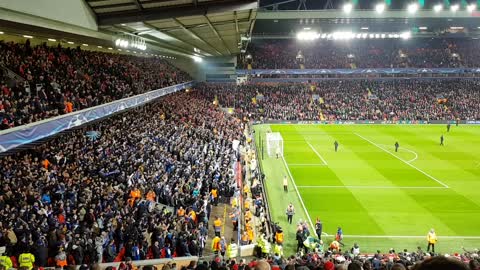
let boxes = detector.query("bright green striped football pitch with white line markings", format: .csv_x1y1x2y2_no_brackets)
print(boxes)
255,125,480,255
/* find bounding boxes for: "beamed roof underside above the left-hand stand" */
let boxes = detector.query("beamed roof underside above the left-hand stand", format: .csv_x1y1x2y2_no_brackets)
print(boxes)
85,0,257,56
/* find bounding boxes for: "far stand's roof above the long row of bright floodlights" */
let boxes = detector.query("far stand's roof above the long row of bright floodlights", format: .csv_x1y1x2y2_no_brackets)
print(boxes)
252,10,480,38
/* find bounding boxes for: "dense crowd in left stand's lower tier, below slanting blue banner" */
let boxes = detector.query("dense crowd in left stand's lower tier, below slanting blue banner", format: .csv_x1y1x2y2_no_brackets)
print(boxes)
0,91,243,266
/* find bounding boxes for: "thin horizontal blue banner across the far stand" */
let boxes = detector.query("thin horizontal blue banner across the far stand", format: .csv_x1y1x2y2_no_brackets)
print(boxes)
237,68,480,75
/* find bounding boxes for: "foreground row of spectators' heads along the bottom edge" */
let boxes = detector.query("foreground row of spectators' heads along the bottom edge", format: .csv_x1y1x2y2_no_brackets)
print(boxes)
188,250,480,270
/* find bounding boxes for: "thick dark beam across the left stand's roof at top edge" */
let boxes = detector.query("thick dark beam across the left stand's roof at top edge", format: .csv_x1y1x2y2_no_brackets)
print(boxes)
93,0,257,26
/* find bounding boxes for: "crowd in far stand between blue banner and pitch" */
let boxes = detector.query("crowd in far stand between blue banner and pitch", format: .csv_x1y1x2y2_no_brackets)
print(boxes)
202,79,480,121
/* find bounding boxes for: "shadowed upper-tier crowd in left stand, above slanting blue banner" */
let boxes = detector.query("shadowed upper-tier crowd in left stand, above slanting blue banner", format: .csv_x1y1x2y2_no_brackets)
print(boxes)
0,40,189,129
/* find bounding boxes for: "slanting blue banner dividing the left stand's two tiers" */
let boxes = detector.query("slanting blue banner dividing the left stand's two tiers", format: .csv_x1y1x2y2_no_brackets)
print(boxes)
0,82,193,153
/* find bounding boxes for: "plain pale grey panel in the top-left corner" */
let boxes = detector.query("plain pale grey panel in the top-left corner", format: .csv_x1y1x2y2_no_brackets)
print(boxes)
0,0,98,31
